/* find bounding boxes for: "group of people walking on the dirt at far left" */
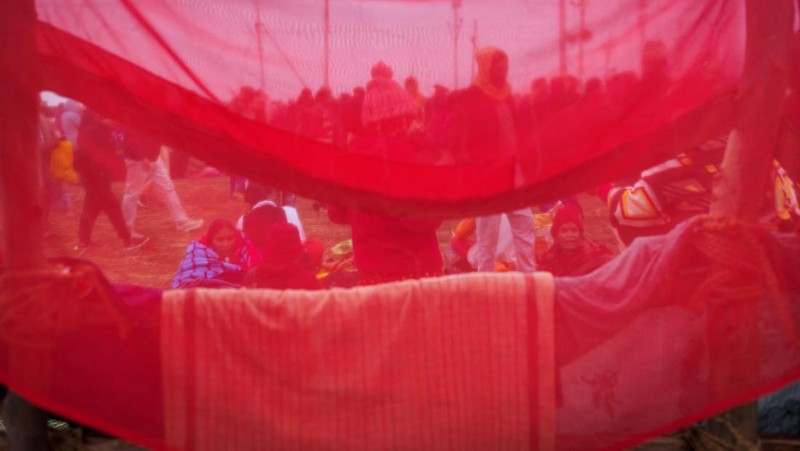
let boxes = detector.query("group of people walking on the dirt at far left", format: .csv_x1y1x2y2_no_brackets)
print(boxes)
39,100,203,251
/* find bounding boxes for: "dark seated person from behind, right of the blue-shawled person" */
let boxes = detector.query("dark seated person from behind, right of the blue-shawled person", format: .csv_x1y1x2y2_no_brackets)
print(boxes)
242,222,320,290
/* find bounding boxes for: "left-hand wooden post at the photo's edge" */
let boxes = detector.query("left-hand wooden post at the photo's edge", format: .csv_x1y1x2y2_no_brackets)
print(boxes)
0,0,49,451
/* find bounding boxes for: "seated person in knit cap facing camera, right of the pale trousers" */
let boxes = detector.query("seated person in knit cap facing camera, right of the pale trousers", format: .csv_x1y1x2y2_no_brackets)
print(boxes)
538,206,614,277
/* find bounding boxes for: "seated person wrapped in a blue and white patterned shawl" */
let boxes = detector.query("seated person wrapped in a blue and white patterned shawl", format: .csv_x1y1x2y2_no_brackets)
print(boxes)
172,218,253,288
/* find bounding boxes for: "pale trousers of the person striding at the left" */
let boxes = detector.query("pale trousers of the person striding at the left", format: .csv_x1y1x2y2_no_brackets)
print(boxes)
122,158,189,232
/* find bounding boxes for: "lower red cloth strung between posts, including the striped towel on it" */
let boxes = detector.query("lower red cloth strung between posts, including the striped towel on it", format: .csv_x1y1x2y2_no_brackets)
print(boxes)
0,220,800,449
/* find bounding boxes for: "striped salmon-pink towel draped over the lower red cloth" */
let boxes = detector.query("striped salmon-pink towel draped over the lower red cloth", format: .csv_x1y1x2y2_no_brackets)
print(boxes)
162,273,555,450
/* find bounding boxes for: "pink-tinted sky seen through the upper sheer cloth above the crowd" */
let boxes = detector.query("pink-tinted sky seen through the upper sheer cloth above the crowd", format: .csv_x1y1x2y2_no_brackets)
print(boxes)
37,0,736,99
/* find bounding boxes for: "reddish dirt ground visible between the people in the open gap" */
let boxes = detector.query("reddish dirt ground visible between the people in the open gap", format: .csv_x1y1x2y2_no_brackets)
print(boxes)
40,177,616,288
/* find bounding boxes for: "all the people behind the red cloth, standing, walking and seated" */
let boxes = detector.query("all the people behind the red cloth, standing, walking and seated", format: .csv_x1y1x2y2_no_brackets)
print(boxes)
34,42,800,289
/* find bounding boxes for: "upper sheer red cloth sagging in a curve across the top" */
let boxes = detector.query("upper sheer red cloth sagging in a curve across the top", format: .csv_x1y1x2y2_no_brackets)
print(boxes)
32,0,744,215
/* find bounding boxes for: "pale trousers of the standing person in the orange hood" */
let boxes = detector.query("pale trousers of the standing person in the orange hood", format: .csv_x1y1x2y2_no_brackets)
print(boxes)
475,208,535,272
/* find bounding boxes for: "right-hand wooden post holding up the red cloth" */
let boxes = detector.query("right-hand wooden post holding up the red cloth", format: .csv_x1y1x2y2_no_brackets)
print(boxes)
710,0,794,443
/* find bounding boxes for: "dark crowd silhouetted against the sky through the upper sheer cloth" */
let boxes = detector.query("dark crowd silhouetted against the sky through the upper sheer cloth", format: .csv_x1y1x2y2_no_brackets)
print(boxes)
229,41,670,168
